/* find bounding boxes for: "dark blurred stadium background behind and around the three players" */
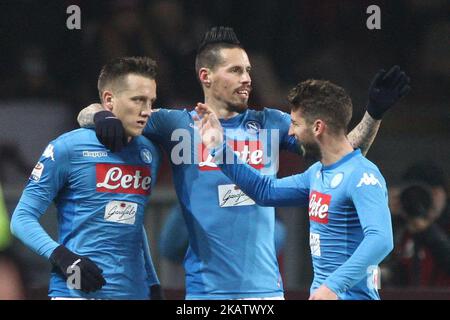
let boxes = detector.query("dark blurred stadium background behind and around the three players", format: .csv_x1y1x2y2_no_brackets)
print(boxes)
0,0,450,299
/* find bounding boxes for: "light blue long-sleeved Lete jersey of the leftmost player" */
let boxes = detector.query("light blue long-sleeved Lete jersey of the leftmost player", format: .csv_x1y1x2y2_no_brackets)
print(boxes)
11,129,160,299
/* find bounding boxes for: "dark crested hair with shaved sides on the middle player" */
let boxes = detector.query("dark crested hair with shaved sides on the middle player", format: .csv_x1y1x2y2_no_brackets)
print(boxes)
195,27,242,75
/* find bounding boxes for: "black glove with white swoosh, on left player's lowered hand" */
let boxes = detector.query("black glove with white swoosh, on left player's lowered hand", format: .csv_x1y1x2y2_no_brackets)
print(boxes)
50,245,106,293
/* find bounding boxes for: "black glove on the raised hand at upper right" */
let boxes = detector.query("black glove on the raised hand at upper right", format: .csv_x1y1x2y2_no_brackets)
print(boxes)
367,66,411,120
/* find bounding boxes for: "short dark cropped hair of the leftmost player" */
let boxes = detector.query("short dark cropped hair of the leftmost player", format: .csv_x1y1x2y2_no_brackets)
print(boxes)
97,57,156,99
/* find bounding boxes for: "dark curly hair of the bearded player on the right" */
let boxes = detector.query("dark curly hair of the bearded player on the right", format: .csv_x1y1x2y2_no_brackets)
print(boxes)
288,80,353,133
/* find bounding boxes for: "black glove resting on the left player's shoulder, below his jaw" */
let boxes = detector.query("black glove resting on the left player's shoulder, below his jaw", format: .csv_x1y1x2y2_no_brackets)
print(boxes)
94,111,127,152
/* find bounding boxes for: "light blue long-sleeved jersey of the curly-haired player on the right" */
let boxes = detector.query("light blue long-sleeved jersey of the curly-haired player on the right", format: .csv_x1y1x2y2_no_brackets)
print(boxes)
219,147,393,300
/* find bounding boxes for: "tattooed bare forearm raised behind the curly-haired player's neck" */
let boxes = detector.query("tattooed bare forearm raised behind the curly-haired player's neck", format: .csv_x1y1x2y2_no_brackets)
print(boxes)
348,112,381,155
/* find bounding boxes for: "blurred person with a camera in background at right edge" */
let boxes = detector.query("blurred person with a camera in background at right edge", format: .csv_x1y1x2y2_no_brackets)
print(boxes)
382,162,450,287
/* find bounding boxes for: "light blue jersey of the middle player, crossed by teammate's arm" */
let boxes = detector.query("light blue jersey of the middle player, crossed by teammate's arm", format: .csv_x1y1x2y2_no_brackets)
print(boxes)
144,109,297,299
